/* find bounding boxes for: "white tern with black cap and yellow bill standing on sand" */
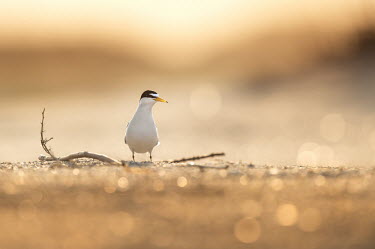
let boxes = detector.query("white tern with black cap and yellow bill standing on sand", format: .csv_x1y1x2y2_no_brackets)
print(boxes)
125,90,168,161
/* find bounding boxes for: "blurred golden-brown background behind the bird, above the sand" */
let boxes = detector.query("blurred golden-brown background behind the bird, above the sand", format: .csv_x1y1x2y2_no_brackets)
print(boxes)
0,0,375,166
